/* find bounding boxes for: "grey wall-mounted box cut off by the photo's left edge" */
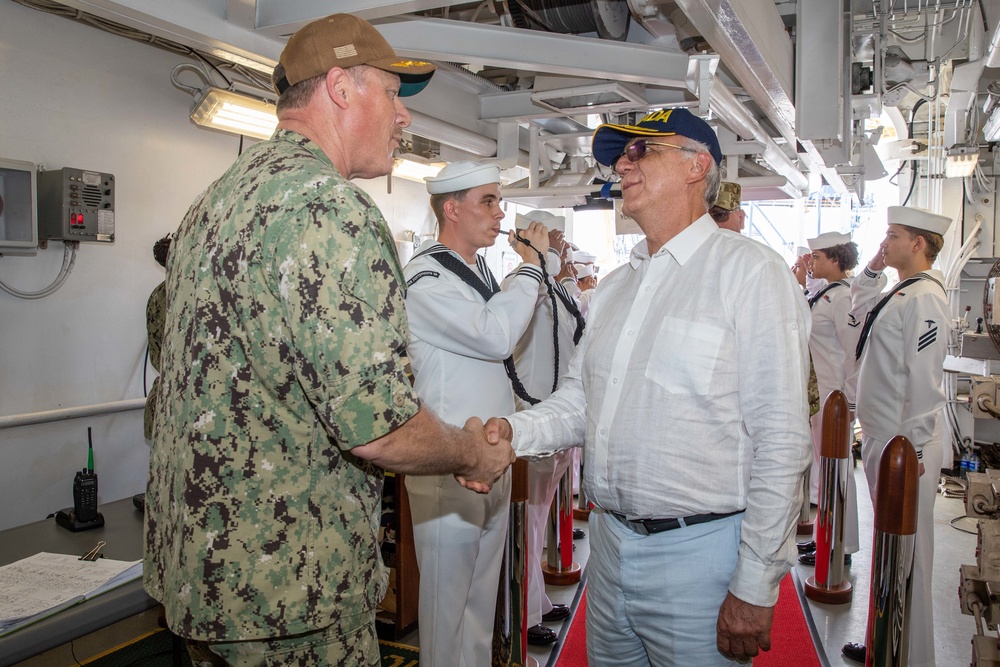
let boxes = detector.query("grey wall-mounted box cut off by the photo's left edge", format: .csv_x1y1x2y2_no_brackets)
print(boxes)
0,159,38,255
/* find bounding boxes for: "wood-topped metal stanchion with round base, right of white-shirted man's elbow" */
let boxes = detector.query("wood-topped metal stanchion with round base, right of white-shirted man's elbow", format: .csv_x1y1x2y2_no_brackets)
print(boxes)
806,391,853,604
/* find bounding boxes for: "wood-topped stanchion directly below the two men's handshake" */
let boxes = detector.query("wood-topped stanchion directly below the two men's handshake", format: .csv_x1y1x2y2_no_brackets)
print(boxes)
493,460,538,667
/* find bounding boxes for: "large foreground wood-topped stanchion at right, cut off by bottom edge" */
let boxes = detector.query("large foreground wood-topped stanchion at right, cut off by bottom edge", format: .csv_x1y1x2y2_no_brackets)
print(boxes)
865,435,920,667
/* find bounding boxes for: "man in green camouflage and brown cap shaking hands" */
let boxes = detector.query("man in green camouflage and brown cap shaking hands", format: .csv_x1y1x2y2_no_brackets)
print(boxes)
144,14,513,666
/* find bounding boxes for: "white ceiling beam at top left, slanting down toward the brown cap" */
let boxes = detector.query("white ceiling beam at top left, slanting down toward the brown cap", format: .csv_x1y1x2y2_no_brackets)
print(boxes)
60,0,285,74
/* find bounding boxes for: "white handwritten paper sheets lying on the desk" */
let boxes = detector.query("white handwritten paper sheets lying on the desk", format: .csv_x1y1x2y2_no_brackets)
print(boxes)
0,552,142,634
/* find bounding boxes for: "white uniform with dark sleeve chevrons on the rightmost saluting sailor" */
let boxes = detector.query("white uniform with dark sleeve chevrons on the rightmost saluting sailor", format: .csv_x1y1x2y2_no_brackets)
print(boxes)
851,268,951,667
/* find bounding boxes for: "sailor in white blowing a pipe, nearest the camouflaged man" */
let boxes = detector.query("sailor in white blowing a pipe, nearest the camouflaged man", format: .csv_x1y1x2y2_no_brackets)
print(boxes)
403,162,548,667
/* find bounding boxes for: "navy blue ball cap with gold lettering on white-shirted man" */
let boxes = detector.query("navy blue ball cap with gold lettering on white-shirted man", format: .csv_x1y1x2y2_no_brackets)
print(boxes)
592,109,722,166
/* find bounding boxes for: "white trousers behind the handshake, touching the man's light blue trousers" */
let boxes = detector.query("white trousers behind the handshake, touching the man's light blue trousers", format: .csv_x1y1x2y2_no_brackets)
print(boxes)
527,447,578,628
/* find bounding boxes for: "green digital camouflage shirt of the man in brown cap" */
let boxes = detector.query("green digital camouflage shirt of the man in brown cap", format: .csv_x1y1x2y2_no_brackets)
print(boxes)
143,130,418,648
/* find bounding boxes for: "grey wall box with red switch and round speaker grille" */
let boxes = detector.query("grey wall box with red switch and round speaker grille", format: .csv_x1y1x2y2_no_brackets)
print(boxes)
38,167,115,242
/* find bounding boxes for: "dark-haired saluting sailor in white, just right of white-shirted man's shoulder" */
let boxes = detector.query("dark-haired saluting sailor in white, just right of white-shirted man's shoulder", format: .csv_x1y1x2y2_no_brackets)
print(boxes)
799,232,860,565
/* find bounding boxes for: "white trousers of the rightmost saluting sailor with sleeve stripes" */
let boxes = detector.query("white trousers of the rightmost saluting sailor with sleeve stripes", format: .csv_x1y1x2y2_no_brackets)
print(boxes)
861,434,942,667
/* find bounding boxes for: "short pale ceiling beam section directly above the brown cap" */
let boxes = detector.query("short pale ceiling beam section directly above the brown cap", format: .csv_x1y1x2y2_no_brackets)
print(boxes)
254,0,455,37
